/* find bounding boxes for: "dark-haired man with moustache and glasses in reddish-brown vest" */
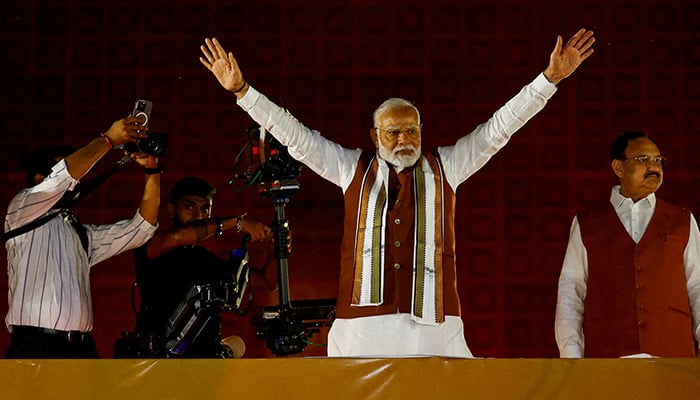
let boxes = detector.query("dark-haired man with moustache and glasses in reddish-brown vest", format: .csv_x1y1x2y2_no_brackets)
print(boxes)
555,132,700,358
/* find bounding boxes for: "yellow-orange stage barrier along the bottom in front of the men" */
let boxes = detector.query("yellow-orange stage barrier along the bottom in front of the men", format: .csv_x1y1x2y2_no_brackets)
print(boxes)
0,358,700,400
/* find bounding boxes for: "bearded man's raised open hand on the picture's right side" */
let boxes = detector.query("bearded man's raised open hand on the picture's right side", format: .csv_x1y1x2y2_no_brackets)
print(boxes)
544,28,595,85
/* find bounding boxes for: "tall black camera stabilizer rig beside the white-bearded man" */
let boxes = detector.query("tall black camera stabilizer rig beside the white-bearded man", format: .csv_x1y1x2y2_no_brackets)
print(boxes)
229,126,335,356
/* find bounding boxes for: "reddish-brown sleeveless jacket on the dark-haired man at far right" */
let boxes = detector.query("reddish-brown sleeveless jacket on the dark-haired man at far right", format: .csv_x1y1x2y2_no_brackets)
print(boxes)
578,198,695,357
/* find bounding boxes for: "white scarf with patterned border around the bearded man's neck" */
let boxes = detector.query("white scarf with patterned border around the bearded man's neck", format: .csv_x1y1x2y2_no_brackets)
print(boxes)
352,155,445,325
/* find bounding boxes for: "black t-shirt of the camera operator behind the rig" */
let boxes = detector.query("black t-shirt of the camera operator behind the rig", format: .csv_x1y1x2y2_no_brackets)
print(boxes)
134,245,237,357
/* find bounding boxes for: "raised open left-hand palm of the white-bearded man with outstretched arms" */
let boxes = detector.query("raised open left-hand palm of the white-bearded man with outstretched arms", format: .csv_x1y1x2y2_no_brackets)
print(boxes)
199,38,246,94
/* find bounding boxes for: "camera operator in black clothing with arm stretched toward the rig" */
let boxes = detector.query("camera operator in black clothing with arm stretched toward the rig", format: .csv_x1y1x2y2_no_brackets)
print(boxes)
134,177,272,358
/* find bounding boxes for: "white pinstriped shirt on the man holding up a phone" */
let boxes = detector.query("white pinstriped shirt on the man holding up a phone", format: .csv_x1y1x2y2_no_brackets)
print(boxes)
5,160,156,332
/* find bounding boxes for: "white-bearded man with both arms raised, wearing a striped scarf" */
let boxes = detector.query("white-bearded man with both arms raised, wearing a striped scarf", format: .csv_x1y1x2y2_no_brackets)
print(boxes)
200,29,595,357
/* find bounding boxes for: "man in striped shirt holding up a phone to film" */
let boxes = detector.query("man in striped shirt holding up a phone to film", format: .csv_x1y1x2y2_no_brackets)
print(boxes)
4,116,160,358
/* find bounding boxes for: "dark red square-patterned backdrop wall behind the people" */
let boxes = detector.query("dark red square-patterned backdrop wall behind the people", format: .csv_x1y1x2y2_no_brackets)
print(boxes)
0,0,700,357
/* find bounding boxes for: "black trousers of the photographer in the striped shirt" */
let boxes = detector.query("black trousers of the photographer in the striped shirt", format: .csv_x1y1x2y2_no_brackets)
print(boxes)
5,326,99,358
